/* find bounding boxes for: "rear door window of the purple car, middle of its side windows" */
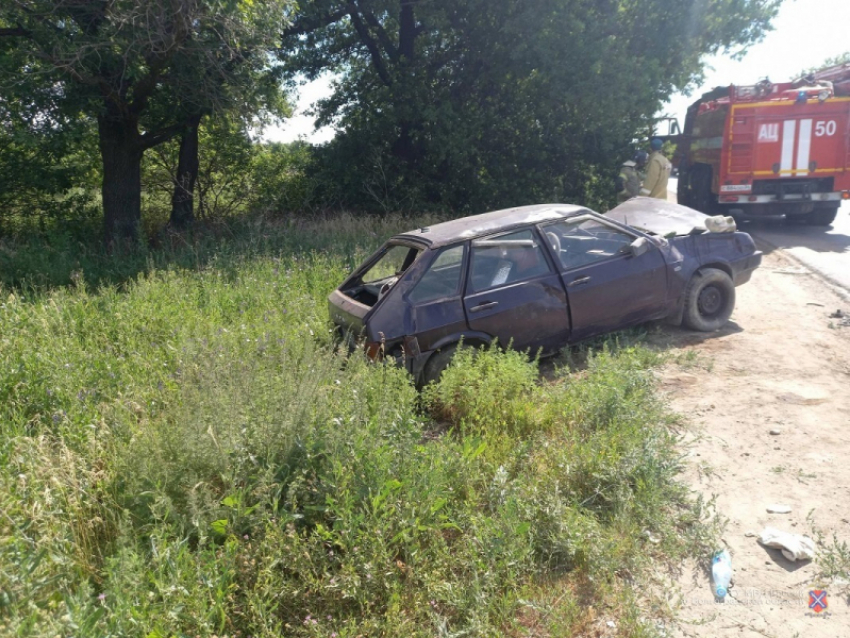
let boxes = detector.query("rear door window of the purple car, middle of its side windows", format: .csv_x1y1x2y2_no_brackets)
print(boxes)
469,228,551,292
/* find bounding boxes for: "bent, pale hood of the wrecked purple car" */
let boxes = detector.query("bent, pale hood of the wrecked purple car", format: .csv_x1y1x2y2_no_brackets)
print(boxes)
605,197,708,237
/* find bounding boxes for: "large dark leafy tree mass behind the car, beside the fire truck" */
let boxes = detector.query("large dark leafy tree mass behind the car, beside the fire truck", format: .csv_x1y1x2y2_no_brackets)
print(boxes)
283,0,779,208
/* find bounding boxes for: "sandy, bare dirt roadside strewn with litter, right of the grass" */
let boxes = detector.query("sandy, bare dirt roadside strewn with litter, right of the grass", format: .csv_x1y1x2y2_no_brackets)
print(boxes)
644,242,850,638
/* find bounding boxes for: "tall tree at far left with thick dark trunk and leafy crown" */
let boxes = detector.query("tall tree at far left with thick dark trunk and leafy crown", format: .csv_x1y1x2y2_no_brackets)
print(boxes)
0,0,288,241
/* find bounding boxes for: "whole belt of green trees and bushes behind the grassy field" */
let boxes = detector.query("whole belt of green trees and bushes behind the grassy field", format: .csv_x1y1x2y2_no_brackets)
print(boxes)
0,0,781,245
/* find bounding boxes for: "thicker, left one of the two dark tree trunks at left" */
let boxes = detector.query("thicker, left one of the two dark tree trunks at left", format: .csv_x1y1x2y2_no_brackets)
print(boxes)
97,114,142,248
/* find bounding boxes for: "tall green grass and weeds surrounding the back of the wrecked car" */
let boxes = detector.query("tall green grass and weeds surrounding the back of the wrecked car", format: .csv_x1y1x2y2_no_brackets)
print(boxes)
0,217,711,638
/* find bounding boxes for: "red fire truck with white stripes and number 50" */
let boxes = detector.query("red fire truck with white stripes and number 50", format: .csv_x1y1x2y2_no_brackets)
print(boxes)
673,64,850,226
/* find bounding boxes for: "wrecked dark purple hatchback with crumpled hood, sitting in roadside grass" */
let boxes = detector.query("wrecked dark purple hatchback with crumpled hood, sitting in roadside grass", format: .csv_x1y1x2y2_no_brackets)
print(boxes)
329,197,761,386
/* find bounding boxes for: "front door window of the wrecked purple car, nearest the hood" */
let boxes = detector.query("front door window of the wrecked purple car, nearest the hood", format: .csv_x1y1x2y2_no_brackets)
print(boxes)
542,217,635,269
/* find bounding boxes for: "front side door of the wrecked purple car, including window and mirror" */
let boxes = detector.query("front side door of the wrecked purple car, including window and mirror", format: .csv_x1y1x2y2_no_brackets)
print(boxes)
541,215,667,341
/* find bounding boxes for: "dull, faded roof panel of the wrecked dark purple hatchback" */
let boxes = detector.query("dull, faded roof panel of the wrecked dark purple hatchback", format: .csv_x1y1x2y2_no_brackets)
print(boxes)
396,204,592,247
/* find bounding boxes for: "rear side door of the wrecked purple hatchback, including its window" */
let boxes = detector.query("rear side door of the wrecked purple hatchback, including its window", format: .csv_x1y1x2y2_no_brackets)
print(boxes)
463,228,569,353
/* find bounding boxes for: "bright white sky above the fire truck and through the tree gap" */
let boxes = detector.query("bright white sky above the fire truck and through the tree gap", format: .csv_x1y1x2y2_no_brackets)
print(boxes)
262,0,850,143
